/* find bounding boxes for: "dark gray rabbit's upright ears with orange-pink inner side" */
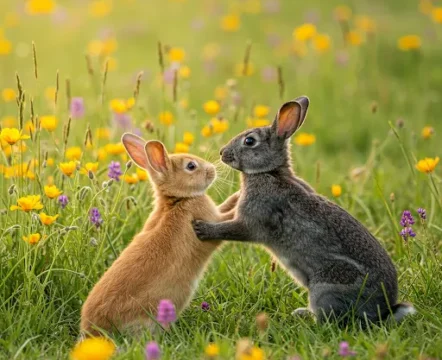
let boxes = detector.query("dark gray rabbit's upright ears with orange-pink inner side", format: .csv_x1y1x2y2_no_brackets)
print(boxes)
272,96,310,139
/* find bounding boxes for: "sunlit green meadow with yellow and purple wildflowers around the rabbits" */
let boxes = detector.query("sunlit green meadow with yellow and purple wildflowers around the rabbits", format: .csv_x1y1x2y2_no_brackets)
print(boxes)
0,0,442,360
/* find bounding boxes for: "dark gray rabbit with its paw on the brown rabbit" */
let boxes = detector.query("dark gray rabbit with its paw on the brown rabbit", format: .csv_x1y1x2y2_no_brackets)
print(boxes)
194,96,415,324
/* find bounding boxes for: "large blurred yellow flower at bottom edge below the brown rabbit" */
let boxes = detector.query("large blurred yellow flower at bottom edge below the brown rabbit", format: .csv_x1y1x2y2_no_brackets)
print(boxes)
71,337,115,360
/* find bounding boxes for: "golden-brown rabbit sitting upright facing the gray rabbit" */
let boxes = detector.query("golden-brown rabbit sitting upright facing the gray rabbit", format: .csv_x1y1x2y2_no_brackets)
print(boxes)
81,133,238,335
